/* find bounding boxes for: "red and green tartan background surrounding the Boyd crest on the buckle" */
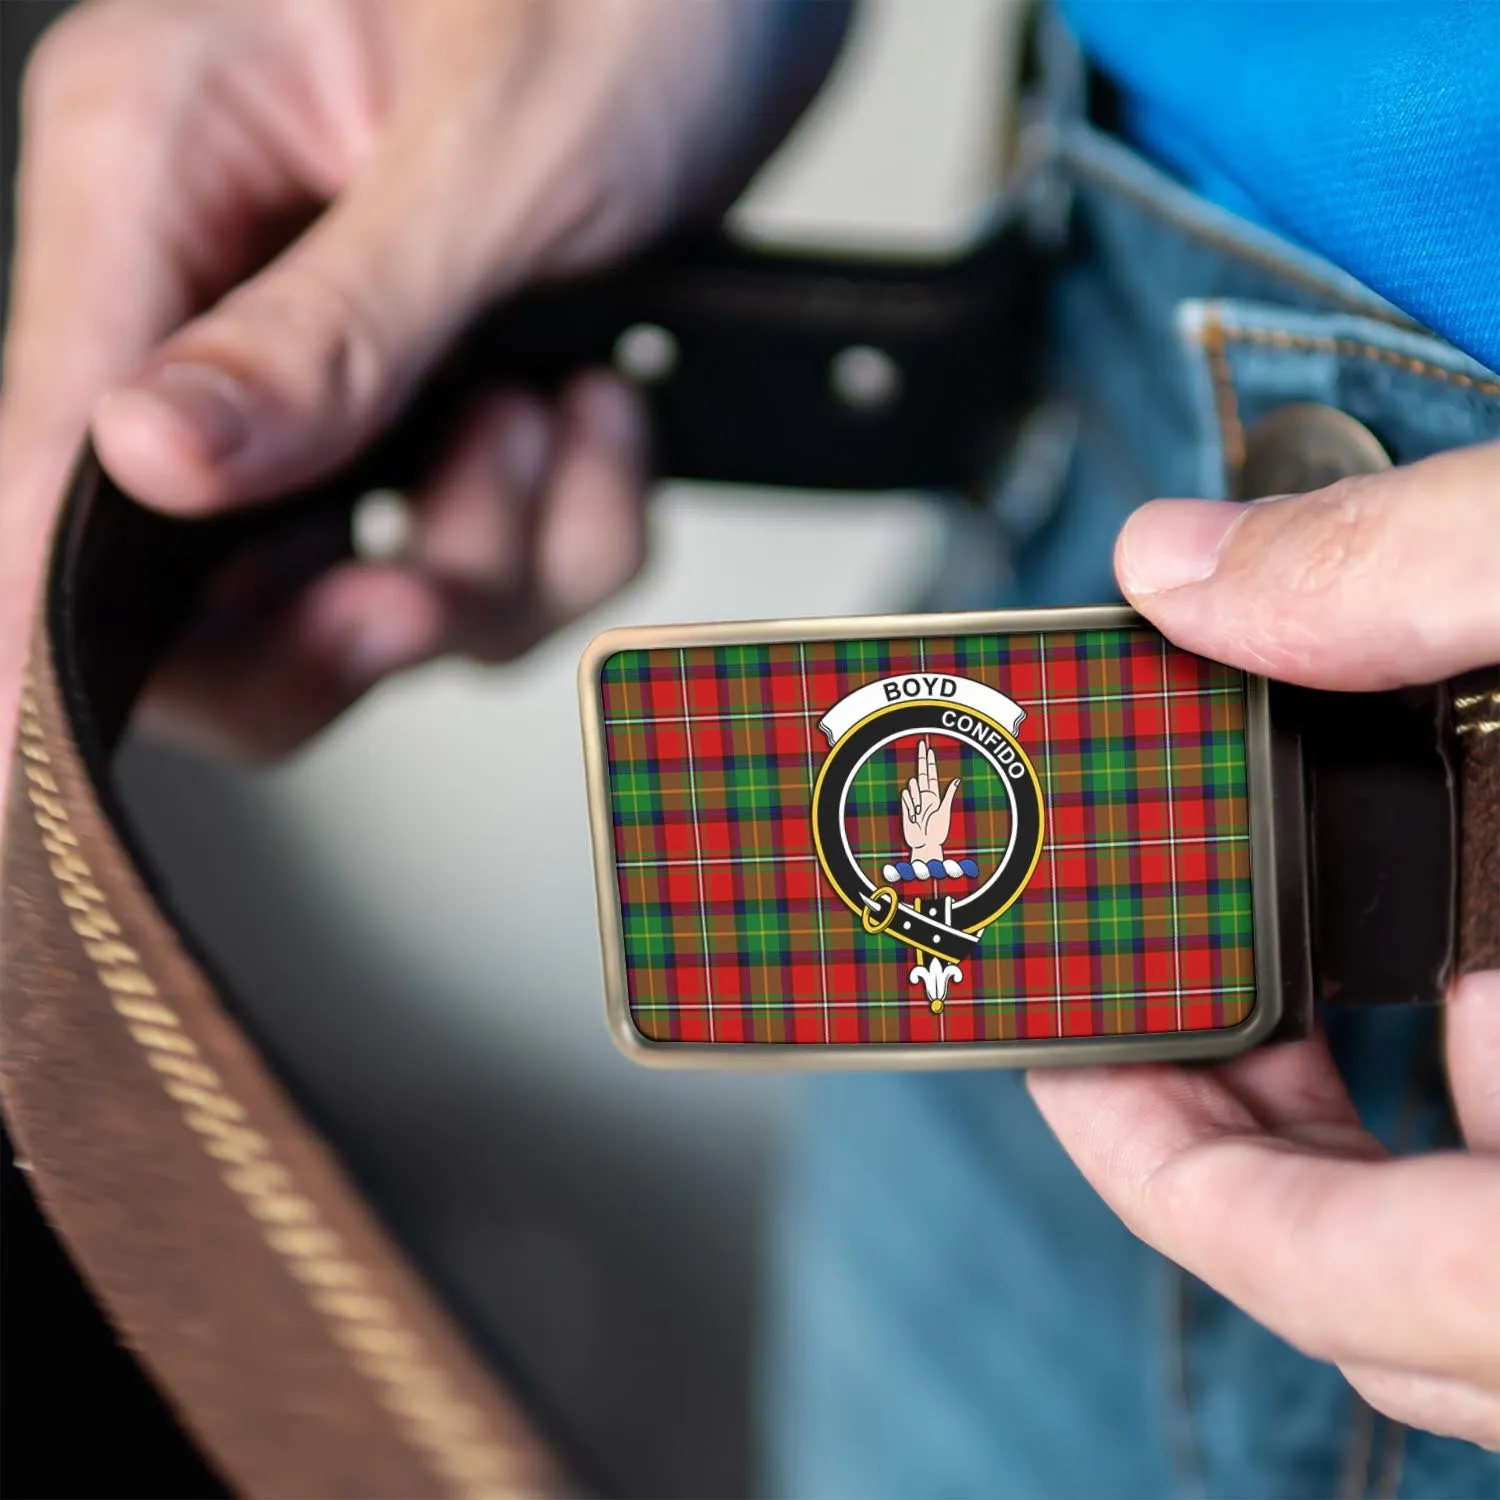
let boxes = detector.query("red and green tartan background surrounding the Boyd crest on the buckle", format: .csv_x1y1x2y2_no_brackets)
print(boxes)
600,627,1256,1046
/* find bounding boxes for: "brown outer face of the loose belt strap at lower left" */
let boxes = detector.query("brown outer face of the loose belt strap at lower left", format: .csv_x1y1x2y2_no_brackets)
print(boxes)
0,603,570,1500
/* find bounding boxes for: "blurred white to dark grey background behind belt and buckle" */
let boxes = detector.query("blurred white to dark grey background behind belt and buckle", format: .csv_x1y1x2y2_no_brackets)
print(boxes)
0,0,1014,1496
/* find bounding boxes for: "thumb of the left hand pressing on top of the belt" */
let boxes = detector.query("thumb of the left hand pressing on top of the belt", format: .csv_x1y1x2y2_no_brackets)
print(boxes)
93,126,534,512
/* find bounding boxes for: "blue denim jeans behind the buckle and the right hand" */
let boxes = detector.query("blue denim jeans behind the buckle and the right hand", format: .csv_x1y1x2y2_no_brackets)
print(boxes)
762,90,1500,1500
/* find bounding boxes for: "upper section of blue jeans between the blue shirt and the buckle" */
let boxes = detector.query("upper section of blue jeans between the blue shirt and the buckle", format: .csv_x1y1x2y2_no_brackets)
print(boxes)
971,42,1500,605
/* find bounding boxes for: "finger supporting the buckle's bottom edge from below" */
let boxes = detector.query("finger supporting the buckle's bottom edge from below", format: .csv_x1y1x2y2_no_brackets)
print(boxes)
1032,1044,1500,1383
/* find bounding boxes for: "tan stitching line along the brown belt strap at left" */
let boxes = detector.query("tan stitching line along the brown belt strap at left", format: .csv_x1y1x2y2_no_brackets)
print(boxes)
20,674,518,1500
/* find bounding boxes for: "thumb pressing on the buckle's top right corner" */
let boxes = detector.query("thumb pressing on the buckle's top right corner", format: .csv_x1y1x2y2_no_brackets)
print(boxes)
1115,444,1500,690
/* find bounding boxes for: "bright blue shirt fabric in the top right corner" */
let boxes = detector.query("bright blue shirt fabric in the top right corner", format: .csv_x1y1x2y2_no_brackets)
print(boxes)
1062,0,1500,369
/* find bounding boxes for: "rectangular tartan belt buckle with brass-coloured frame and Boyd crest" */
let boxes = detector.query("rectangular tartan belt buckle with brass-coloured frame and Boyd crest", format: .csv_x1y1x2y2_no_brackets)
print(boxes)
581,608,1283,1068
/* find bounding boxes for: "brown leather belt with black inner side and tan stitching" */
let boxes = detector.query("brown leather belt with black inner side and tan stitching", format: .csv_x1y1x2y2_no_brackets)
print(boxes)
0,228,1500,1497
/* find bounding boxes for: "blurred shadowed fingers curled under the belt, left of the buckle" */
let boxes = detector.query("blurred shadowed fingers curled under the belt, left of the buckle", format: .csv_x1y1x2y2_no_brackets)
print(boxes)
144,377,645,758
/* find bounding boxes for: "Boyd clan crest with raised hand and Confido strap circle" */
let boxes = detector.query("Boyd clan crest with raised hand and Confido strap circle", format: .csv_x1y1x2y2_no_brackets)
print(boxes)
812,672,1044,1013
